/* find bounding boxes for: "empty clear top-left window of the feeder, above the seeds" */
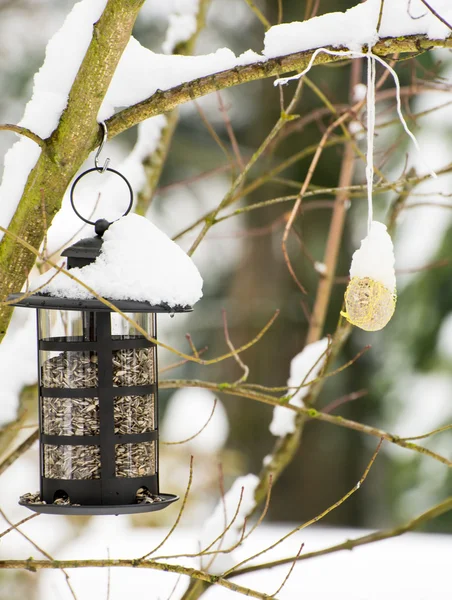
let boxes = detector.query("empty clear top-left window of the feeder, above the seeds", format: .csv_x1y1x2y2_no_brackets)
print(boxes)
38,309,96,342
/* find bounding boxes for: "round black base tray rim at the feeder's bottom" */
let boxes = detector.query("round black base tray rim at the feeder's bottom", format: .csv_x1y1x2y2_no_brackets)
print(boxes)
19,494,179,515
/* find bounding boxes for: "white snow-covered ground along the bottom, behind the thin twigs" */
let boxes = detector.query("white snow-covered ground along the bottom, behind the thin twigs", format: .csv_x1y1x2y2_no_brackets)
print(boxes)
19,517,452,600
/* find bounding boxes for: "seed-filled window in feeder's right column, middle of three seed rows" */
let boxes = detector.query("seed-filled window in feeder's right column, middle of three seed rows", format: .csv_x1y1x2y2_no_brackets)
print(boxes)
114,394,155,434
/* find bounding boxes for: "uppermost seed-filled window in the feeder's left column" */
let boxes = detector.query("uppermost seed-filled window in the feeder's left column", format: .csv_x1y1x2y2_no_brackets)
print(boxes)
39,350,97,388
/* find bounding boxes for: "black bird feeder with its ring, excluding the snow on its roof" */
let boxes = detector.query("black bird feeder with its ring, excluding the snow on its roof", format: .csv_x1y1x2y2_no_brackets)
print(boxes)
9,163,191,515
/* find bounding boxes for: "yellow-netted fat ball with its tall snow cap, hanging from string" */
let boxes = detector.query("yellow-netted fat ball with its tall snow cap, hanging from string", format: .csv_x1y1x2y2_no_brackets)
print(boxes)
341,221,396,331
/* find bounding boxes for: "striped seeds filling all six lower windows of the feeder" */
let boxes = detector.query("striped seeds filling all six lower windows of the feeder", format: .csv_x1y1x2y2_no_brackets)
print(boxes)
41,348,156,479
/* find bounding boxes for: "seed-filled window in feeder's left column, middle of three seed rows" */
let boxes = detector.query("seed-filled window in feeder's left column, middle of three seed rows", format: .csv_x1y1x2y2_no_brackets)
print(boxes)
42,398,99,435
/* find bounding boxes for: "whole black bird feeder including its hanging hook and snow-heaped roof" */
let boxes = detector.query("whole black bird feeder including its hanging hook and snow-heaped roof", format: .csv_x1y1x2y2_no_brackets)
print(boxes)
9,137,202,515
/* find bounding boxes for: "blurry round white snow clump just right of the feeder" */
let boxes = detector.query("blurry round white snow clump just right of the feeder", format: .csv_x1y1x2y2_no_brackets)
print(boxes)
160,388,229,454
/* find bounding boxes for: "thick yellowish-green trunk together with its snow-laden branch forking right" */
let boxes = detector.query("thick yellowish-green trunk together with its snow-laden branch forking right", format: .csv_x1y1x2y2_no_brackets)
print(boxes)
0,30,452,341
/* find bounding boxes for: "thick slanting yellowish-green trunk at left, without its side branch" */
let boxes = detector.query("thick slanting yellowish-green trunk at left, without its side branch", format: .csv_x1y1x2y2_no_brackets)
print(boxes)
0,0,144,340
